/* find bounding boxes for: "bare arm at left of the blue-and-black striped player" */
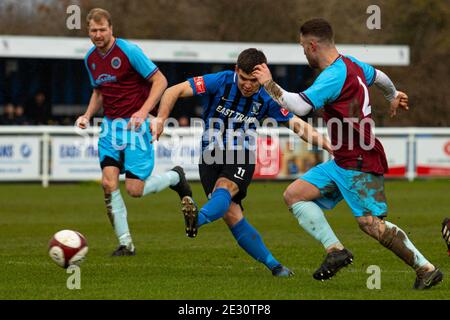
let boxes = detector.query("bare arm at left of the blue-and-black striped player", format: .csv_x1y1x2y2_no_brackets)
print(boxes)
151,81,194,141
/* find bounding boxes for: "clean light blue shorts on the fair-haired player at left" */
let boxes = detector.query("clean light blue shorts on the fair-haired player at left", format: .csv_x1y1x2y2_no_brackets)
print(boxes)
98,117,155,180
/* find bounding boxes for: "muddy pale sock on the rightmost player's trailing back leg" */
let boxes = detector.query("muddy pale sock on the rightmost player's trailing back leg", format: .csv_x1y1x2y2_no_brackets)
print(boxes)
380,220,430,270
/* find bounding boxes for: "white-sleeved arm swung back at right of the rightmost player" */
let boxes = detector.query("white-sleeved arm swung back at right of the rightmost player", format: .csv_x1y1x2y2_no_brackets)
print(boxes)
374,69,409,117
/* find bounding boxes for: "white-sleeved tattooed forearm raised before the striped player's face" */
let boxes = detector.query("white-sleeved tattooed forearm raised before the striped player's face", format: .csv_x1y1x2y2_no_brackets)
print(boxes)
252,63,312,116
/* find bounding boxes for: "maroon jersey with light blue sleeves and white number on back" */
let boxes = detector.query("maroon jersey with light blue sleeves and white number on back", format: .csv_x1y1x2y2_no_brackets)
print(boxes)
300,55,388,174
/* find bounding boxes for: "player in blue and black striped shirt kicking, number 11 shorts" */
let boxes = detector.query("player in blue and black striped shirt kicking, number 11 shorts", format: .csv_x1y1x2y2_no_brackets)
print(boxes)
152,48,331,277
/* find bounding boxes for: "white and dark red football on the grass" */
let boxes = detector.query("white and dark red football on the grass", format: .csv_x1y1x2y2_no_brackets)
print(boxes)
48,230,88,268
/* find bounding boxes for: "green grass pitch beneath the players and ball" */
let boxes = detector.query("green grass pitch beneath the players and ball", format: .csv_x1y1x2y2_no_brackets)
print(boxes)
0,180,450,300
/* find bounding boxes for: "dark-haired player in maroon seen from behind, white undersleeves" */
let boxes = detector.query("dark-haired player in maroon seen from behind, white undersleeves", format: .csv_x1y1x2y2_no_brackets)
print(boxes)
253,19,443,289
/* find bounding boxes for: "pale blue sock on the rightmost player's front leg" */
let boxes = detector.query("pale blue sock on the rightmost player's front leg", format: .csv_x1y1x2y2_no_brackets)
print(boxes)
291,201,340,249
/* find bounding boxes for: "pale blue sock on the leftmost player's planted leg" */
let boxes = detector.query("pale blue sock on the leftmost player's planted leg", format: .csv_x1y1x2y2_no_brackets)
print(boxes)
106,189,133,247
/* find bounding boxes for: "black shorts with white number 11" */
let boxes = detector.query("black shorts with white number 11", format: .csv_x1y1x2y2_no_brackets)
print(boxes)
198,151,255,208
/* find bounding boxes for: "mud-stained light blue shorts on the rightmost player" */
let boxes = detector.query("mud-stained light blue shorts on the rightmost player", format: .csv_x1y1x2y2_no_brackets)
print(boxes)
300,160,387,217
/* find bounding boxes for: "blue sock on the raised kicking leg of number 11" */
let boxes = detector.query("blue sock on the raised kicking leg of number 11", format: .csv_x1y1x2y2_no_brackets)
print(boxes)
197,188,231,227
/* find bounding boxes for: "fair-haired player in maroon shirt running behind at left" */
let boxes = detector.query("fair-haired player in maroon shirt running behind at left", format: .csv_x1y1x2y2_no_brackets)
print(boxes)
76,8,192,256
